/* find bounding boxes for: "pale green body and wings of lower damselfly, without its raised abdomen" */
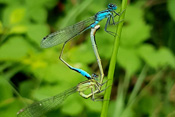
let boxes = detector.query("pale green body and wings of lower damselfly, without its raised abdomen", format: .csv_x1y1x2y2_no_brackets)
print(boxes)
17,78,105,117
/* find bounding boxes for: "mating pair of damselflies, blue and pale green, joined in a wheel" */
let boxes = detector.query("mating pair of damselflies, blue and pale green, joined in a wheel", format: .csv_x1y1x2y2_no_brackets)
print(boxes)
17,4,123,117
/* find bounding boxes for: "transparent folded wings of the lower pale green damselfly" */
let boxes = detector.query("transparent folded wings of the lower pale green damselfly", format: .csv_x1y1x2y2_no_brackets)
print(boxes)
17,87,77,117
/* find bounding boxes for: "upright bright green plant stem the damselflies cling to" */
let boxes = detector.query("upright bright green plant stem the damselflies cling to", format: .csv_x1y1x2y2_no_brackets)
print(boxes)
101,0,128,117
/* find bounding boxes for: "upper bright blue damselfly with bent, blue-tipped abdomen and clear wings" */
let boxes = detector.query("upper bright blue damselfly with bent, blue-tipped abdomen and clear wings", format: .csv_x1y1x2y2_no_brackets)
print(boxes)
41,4,119,79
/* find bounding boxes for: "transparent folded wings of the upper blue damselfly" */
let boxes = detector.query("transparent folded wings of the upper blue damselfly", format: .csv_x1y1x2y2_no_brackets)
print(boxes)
41,16,95,48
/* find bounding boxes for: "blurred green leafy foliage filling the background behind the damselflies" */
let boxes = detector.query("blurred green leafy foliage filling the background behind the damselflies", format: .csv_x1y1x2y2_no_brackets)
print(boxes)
0,0,175,117
